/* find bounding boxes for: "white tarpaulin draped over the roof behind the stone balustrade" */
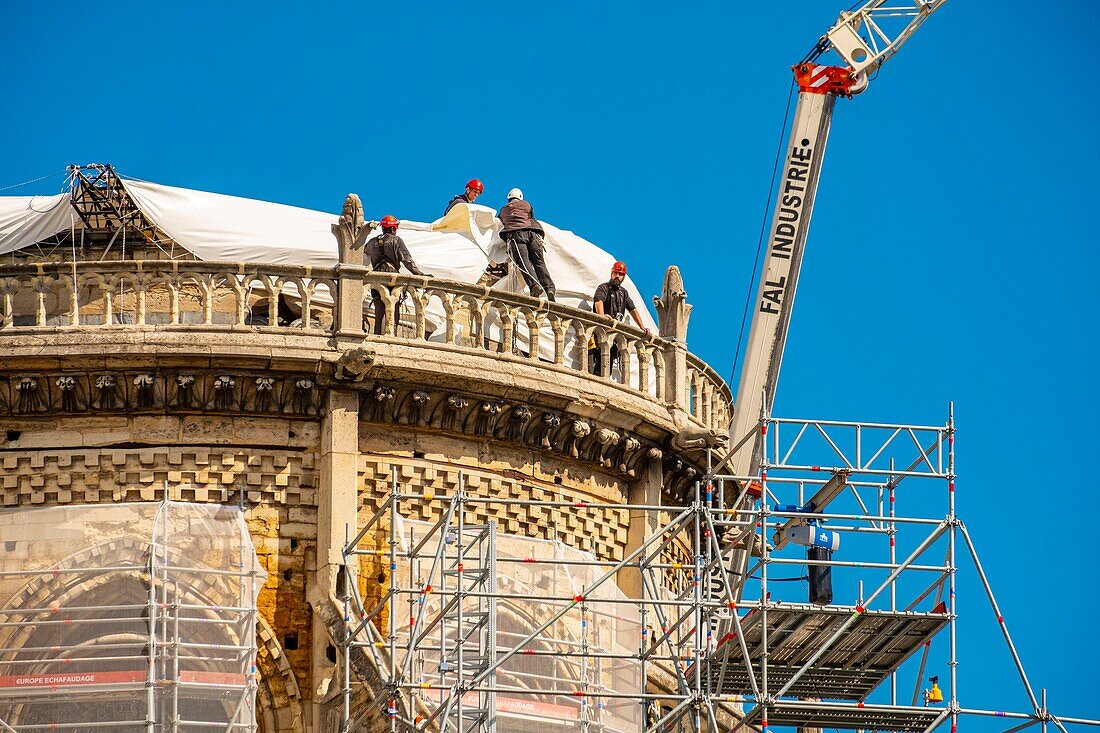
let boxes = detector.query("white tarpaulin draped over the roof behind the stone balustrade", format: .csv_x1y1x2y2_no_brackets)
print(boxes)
0,179,657,331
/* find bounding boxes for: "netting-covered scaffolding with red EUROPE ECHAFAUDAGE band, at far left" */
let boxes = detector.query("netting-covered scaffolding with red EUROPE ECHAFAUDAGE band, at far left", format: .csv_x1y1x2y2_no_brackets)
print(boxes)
0,501,266,733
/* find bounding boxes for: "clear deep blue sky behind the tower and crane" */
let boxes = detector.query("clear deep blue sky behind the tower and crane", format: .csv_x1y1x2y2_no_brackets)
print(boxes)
0,0,1100,727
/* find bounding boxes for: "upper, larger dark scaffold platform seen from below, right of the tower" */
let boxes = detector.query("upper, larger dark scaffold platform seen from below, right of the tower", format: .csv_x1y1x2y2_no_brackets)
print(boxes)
702,603,948,695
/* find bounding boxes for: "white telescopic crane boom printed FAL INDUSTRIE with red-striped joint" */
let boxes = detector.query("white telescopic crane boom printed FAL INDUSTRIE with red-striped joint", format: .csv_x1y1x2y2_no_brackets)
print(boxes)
716,0,946,477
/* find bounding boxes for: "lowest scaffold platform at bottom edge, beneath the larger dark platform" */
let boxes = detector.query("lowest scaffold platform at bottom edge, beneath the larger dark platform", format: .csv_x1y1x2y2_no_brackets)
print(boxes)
746,700,945,733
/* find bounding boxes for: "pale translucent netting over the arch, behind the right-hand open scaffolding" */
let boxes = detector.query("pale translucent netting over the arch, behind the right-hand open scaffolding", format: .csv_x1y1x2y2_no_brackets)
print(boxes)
394,512,645,733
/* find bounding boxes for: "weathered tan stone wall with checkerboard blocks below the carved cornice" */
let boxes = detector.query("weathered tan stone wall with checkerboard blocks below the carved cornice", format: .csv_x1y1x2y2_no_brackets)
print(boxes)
0,402,660,731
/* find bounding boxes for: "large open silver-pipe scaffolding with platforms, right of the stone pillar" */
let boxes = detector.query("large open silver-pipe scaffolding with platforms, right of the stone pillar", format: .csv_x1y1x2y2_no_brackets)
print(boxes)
340,416,1100,733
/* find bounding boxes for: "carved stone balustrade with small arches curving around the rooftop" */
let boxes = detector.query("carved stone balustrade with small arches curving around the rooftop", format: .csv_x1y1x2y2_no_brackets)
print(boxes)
0,260,730,433
